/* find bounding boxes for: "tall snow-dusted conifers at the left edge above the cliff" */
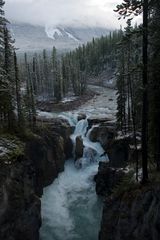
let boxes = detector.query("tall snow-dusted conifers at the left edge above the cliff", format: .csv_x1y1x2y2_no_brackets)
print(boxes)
0,1,24,132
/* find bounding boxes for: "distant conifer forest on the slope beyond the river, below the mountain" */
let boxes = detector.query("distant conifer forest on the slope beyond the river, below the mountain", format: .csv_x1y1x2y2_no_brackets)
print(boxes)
20,31,122,101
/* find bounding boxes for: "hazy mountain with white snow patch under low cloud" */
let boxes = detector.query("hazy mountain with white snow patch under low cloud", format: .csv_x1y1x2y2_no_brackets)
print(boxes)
9,23,109,52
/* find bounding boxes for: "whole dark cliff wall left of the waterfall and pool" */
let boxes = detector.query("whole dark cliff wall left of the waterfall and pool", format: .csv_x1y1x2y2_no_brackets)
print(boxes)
0,121,71,240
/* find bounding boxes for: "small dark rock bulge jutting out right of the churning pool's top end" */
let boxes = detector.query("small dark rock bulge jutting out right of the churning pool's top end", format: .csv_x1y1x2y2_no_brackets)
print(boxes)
94,162,125,197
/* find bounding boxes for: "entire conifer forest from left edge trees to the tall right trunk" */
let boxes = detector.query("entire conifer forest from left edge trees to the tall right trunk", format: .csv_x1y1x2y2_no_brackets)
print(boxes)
0,0,160,185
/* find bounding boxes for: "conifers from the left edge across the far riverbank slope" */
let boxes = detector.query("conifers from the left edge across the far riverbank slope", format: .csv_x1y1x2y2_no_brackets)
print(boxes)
0,0,122,131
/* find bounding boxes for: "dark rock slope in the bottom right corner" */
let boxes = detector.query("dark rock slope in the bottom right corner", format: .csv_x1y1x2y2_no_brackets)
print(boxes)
99,187,160,240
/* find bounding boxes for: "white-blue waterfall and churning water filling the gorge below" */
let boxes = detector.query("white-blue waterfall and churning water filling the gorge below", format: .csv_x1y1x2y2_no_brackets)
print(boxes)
41,115,108,240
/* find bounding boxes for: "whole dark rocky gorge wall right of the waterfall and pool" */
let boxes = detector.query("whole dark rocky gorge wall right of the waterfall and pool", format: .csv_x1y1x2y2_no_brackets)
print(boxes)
91,124,160,240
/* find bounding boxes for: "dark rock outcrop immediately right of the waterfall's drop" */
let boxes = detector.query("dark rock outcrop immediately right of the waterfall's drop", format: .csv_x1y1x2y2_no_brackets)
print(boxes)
89,119,131,168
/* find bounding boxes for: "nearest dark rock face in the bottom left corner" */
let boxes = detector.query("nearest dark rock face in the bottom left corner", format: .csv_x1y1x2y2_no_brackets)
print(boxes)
0,157,41,240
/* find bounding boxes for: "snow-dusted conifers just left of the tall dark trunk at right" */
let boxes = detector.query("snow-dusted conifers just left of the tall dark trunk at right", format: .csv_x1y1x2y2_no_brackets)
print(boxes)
117,20,142,133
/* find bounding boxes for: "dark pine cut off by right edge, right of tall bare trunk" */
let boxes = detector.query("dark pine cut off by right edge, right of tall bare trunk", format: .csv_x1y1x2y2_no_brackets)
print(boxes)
149,1,160,171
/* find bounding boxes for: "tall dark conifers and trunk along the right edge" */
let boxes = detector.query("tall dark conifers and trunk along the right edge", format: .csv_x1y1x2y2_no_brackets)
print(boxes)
116,0,160,182
